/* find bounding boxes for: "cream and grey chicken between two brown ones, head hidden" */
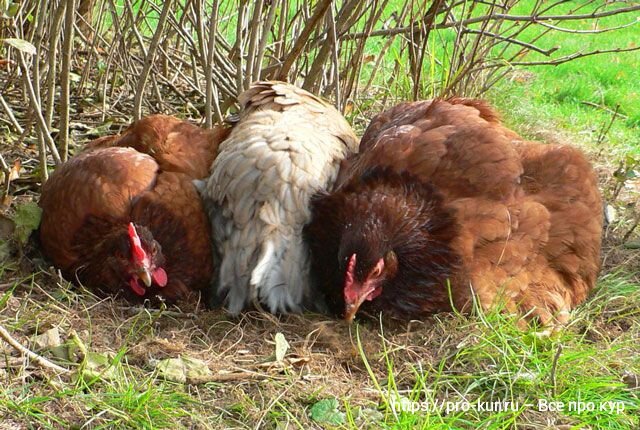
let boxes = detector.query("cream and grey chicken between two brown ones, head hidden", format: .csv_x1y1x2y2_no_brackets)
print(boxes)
202,82,358,314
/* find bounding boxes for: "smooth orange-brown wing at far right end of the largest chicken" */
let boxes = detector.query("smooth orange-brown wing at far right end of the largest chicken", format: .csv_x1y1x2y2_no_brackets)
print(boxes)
516,142,603,304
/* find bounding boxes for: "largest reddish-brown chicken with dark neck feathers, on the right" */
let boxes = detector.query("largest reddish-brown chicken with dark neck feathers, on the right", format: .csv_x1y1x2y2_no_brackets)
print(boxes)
304,98,602,326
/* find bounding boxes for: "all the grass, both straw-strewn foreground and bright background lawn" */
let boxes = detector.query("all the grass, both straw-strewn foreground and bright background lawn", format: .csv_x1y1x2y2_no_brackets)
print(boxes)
0,2,640,429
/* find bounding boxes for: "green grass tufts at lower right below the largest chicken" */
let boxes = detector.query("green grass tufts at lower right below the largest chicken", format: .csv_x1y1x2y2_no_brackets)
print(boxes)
348,276,640,429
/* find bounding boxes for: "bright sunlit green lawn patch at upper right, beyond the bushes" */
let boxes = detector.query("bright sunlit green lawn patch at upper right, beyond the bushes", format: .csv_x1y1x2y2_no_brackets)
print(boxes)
489,2,640,158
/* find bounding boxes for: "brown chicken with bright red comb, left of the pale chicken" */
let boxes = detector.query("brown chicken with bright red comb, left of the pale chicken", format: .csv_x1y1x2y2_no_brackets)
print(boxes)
40,115,228,302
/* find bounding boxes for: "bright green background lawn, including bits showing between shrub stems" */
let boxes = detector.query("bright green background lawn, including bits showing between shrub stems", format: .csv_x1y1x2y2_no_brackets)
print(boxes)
362,0,640,159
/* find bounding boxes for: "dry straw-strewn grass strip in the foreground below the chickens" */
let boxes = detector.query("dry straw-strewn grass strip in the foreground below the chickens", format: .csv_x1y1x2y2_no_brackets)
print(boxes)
0,273,640,429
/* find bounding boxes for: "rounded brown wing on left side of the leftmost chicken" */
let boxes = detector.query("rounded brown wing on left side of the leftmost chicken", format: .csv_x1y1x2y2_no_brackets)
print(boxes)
39,148,158,270
